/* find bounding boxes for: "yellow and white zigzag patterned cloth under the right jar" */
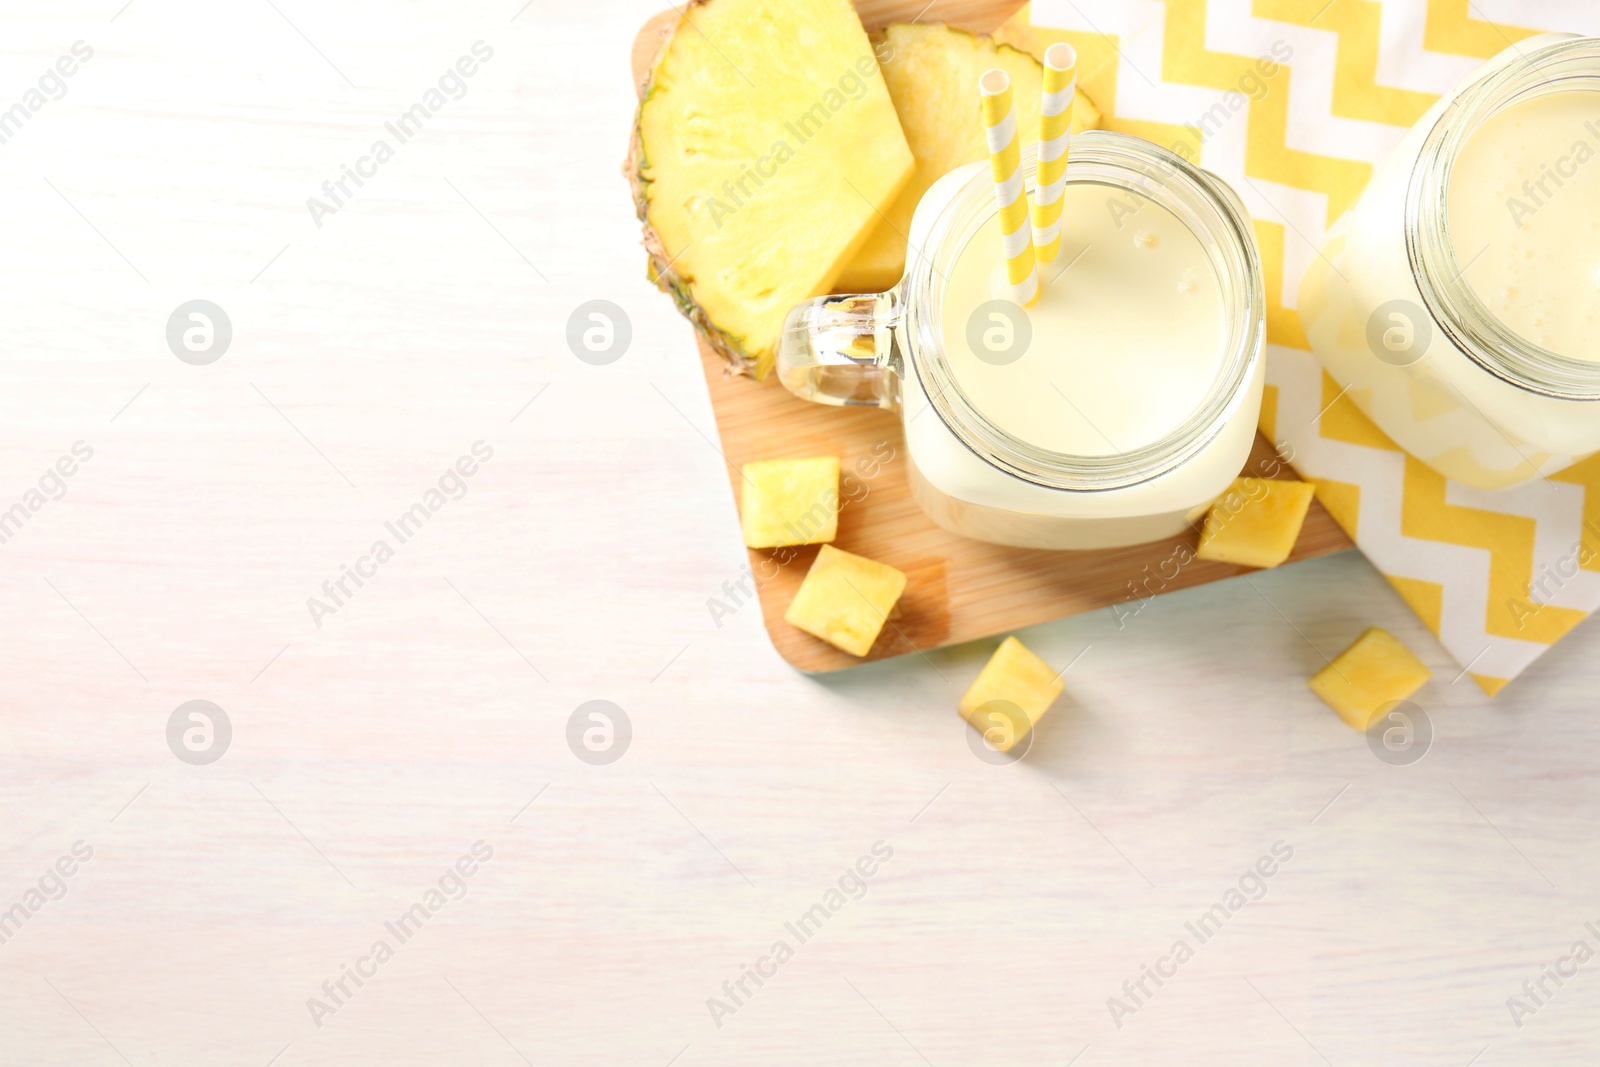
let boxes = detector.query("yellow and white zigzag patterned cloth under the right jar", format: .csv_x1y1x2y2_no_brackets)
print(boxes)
997,0,1600,694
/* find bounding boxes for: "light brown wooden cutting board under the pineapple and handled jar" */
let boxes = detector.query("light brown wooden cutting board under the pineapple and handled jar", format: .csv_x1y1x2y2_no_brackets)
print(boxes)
634,0,1350,672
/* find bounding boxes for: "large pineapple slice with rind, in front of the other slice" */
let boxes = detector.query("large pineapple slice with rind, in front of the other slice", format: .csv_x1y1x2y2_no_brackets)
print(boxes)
627,0,914,378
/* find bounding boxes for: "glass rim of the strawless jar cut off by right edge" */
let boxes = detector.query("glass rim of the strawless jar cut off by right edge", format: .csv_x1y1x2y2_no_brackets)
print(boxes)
1405,37,1600,402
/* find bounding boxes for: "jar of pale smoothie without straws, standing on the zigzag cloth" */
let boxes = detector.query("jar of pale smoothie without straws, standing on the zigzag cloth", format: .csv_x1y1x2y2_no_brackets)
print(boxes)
1298,34,1600,490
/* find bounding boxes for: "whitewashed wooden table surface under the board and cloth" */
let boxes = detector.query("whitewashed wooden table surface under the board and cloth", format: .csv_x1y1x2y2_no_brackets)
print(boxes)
0,0,1600,1067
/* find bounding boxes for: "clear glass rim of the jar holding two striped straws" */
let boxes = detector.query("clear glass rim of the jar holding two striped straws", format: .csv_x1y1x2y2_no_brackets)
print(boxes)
902,130,1266,491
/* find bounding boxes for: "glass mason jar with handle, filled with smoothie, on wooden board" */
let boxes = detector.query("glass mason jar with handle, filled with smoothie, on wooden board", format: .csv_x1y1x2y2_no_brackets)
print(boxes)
778,131,1266,549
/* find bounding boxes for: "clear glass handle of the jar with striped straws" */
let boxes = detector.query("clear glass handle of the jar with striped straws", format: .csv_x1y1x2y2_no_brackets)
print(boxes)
778,290,902,411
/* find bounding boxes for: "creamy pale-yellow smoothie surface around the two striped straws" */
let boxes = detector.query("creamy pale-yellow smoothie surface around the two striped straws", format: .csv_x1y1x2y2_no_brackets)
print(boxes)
942,184,1224,456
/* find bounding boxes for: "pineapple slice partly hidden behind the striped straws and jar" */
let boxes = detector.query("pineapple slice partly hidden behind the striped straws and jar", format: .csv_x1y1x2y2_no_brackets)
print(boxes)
834,22,1099,293
